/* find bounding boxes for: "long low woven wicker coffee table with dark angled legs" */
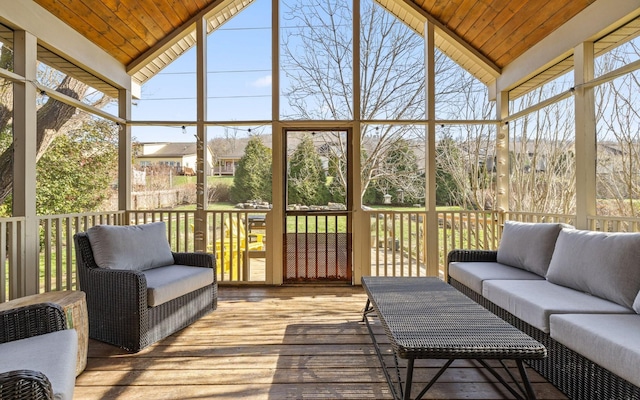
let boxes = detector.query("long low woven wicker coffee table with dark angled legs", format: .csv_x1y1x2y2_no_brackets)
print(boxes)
362,277,547,399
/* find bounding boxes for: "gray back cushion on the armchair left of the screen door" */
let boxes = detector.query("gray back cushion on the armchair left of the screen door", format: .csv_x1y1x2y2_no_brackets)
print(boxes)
87,222,174,271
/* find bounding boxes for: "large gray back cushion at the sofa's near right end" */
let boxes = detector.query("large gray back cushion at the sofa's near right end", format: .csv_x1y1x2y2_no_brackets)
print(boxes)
547,229,640,308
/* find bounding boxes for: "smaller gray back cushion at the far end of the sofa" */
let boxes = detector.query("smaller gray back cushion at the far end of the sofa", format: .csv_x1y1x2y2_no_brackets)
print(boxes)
497,221,568,276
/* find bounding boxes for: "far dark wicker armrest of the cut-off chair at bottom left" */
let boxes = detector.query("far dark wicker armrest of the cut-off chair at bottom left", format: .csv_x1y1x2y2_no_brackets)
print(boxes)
0,303,67,344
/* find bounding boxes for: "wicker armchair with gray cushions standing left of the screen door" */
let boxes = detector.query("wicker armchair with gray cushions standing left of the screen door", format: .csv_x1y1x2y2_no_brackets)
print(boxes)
74,222,218,352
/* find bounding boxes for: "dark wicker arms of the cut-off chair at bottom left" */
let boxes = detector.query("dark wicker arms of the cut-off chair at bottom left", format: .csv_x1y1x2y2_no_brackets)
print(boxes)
0,303,67,400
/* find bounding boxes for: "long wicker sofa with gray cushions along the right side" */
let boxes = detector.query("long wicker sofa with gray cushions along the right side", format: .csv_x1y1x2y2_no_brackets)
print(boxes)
447,221,640,400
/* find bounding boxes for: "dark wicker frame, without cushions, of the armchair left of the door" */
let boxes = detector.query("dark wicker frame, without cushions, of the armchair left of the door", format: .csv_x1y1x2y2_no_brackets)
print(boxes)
74,232,218,352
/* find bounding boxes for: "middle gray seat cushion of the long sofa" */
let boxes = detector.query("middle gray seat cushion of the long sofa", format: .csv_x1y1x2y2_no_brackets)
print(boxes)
482,280,634,333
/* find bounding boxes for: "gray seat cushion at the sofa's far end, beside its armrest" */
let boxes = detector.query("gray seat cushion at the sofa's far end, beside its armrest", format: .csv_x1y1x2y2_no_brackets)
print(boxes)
449,261,544,294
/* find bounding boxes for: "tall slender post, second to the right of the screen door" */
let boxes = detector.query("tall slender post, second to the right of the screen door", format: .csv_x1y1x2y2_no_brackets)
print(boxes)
424,22,440,277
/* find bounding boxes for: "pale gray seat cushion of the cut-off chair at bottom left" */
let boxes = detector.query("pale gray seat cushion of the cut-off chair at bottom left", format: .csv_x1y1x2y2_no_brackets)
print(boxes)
0,329,78,400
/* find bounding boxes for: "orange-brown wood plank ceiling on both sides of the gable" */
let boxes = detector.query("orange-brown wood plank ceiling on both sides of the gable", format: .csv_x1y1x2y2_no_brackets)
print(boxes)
34,0,595,92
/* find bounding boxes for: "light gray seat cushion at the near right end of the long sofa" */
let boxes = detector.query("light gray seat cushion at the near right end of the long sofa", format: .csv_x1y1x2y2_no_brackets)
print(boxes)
551,314,640,386
